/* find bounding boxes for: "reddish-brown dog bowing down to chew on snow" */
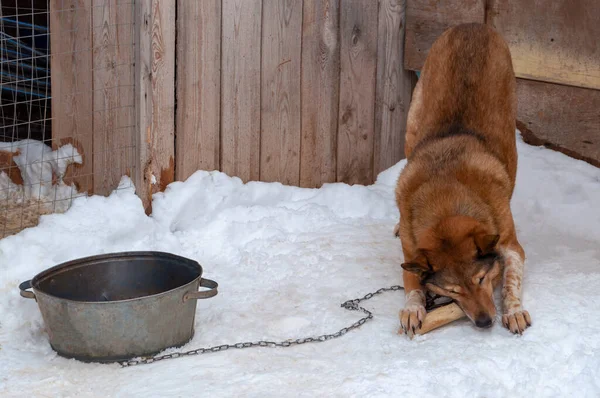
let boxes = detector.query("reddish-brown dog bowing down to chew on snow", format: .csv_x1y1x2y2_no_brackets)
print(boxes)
396,24,531,336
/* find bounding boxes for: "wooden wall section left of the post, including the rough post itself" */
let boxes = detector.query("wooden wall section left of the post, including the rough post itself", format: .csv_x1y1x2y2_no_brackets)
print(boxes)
49,0,176,211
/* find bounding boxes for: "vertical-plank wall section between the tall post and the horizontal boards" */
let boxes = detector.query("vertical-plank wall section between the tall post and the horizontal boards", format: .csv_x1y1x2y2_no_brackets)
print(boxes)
175,0,414,187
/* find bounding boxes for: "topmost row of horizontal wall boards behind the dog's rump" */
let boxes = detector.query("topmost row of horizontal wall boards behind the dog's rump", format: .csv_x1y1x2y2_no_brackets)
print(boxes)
404,0,600,89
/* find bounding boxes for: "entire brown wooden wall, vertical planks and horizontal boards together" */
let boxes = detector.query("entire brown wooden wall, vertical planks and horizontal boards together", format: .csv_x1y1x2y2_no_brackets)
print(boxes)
50,0,600,215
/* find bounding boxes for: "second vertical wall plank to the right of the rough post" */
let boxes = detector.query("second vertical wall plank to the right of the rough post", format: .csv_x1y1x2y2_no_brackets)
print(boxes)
221,0,262,181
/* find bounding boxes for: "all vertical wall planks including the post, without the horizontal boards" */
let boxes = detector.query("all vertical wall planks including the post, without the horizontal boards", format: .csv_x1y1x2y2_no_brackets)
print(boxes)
50,0,415,215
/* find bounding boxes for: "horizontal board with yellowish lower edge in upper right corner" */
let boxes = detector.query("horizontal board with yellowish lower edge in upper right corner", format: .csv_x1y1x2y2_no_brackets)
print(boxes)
487,0,600,89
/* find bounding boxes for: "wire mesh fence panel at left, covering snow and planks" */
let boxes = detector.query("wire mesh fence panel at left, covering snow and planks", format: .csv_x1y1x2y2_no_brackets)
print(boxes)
0,0,136,238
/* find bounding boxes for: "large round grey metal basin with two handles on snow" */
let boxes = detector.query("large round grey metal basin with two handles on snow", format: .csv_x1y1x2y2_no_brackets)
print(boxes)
19,252,217,362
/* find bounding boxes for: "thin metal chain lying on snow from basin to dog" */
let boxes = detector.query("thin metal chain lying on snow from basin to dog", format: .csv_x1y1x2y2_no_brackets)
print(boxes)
121,285,408,367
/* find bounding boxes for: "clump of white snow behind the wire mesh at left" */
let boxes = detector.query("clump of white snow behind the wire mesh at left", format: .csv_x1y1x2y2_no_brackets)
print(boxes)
0,139,83,212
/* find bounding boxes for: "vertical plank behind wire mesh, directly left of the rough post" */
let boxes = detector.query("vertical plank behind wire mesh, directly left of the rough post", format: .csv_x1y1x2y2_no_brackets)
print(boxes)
88,0,135,195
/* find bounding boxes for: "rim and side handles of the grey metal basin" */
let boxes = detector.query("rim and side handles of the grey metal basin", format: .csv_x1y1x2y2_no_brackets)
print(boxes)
19,251,217,305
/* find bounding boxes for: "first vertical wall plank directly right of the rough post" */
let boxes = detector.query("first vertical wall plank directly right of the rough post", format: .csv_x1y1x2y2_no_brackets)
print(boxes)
175,0,221,181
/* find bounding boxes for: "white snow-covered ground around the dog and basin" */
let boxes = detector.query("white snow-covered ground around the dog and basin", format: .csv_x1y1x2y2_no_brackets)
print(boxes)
0,134,600,397
